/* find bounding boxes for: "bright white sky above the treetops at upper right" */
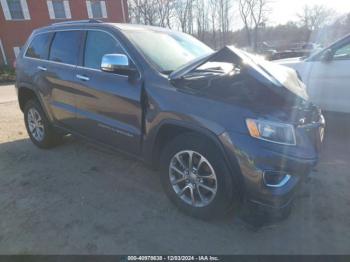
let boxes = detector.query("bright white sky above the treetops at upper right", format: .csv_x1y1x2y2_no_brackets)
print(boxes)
269,0,350,24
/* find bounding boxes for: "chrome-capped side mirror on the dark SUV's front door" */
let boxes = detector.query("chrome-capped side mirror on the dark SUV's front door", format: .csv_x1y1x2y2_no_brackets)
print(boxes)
101,54,135,76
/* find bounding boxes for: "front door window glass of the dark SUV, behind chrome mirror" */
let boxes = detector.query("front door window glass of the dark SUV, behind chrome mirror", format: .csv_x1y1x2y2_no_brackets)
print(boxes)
84,31,124,69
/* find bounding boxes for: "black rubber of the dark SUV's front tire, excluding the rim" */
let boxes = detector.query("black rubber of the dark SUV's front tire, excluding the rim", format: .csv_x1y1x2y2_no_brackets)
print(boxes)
160,133,239,220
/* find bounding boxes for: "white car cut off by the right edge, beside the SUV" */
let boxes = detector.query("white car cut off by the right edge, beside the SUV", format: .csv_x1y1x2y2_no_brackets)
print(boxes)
275,35,350,113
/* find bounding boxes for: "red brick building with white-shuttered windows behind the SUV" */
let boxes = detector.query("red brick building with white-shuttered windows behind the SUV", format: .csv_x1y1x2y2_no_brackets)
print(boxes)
0,0,128,65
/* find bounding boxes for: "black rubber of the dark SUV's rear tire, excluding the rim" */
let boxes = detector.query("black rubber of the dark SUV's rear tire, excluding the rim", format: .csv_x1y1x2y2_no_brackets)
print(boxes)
23,99,63,149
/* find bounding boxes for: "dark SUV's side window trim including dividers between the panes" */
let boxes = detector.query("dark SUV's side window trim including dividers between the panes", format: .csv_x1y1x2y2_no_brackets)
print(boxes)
21,28,142,80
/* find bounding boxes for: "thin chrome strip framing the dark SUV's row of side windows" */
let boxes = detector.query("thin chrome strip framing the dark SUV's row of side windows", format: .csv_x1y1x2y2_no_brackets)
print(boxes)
22,27,141,80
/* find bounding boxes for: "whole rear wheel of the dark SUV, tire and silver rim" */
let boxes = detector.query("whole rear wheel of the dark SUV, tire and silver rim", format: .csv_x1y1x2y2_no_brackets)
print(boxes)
23,99,63,149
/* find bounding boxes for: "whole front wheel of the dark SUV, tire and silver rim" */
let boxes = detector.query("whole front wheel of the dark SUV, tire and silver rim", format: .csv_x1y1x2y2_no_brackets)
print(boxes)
160,133,239,220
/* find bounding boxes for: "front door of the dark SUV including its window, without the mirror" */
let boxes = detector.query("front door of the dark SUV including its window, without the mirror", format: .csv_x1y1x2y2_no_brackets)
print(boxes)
75,30,142,154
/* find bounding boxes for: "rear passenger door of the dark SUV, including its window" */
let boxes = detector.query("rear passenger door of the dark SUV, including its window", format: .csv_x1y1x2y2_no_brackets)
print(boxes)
42,30,83,129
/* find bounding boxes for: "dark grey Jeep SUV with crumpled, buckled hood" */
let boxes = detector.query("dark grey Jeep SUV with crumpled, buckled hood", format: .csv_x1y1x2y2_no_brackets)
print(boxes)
16,21,324,218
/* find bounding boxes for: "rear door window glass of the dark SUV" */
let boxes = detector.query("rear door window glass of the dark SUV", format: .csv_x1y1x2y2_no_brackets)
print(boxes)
49,31,83,65
